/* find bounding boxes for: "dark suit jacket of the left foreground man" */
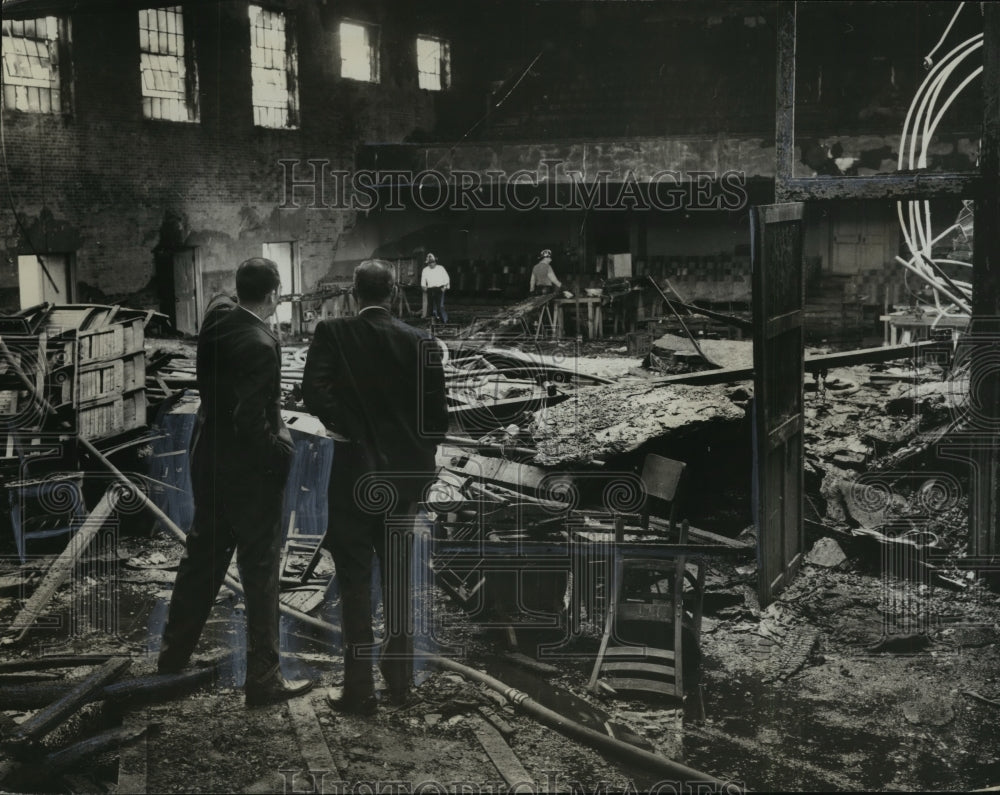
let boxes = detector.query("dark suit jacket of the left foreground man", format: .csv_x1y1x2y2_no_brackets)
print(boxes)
191,298,293,509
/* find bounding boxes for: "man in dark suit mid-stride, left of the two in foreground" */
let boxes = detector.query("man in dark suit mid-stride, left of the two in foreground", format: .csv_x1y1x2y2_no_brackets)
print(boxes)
157,258,313,706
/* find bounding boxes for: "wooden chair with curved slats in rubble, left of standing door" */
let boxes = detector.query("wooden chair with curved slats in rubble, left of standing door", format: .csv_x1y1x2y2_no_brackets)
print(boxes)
587,455,705,701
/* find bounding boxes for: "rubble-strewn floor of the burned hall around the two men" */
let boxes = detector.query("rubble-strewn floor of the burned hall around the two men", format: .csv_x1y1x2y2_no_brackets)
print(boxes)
0,320,1000,792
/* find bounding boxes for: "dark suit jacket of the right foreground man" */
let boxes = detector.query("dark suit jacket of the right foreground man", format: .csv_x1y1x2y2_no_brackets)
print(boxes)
302,308,448,499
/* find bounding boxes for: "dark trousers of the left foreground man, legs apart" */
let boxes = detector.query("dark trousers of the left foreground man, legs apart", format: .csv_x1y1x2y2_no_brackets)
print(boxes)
159,476,283,684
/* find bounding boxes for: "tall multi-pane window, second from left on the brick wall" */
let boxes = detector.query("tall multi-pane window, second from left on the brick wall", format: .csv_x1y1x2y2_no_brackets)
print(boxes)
139,6,198,121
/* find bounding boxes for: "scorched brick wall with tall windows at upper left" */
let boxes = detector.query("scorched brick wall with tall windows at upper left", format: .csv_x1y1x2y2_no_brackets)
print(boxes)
0,0,446,318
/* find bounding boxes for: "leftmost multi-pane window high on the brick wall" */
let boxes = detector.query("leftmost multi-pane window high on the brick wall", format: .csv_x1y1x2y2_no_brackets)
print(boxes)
3,17,62,113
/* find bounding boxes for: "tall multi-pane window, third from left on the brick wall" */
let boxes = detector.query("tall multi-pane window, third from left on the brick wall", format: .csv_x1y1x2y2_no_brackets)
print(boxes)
250,5,298,127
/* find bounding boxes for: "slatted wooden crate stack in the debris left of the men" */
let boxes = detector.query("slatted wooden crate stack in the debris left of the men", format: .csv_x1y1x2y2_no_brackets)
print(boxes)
46,307,146,439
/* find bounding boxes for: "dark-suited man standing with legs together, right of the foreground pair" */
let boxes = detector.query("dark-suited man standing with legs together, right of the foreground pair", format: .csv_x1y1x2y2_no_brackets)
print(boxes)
302,260,448,714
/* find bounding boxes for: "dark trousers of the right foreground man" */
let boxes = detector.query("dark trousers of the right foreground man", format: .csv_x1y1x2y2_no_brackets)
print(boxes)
325,483,417,698
